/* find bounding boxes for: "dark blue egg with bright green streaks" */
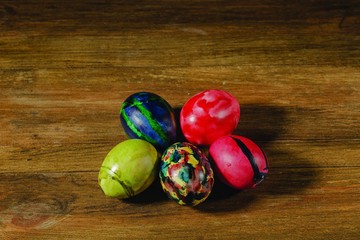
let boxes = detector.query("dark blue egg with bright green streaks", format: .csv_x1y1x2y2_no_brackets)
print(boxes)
120,92,176,150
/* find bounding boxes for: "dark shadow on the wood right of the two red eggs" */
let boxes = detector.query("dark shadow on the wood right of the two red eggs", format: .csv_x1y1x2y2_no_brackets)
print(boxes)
196,104,319,212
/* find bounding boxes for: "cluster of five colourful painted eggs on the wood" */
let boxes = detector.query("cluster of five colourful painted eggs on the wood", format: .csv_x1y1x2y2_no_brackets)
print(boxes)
98,90,268,206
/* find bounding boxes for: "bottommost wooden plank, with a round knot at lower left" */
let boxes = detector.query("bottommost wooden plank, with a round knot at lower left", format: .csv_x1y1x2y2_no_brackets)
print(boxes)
0,170,360,238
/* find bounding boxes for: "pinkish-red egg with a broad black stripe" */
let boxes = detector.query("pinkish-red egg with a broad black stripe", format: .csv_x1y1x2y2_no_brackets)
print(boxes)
209,135,269,190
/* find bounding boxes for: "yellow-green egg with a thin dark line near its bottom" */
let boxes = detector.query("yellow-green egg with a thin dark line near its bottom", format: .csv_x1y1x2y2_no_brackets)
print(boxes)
98,139,159,199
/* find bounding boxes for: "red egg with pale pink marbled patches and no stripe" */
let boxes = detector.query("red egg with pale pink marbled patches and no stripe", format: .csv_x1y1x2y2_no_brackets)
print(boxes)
180,90,240,145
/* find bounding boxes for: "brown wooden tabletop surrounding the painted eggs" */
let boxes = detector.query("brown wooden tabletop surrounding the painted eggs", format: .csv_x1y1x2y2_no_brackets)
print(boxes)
0,0,360,239
